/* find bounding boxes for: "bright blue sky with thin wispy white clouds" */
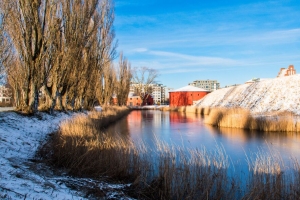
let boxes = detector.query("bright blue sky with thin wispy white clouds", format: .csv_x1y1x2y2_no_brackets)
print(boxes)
114,0,300,89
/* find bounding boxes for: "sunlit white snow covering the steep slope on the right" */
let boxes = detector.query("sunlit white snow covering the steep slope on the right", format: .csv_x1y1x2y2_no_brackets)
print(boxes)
196,74,300,115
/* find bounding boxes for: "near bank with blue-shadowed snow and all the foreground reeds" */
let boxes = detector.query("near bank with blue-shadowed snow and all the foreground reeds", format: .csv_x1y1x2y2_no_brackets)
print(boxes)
0,108,300,199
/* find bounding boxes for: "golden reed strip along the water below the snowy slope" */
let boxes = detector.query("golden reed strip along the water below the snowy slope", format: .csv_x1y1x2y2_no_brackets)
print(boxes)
169,106,300,132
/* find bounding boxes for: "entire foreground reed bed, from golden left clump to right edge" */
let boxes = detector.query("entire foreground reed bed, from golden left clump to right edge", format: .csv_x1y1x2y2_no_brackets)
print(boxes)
44,108,300,199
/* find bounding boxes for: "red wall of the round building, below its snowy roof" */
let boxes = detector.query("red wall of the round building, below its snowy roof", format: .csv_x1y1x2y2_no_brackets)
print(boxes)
169,91,209,107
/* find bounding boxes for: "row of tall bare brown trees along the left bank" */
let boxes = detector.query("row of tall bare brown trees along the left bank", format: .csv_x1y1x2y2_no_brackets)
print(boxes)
0,0,131,112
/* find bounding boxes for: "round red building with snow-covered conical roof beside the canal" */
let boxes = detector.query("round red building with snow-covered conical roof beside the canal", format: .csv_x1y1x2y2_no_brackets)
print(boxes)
169,85,210,107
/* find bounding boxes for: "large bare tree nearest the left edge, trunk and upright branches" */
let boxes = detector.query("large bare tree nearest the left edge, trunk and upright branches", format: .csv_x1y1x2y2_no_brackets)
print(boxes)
1,0,55,112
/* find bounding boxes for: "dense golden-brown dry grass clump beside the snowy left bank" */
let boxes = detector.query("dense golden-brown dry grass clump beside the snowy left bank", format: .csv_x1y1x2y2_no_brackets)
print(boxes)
48,107,145,179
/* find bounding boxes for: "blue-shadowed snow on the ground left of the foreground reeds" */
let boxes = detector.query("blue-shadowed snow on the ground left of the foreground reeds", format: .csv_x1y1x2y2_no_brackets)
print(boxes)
0,111,134,199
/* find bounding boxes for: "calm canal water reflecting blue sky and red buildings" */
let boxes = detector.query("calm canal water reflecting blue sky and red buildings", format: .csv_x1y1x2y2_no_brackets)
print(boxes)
109,110,300,170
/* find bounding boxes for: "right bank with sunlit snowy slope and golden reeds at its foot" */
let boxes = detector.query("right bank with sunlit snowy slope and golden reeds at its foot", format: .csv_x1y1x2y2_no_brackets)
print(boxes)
162,74,300,132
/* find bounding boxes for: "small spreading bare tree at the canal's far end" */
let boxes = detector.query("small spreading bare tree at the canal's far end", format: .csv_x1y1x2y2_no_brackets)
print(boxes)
132,67,158,103
